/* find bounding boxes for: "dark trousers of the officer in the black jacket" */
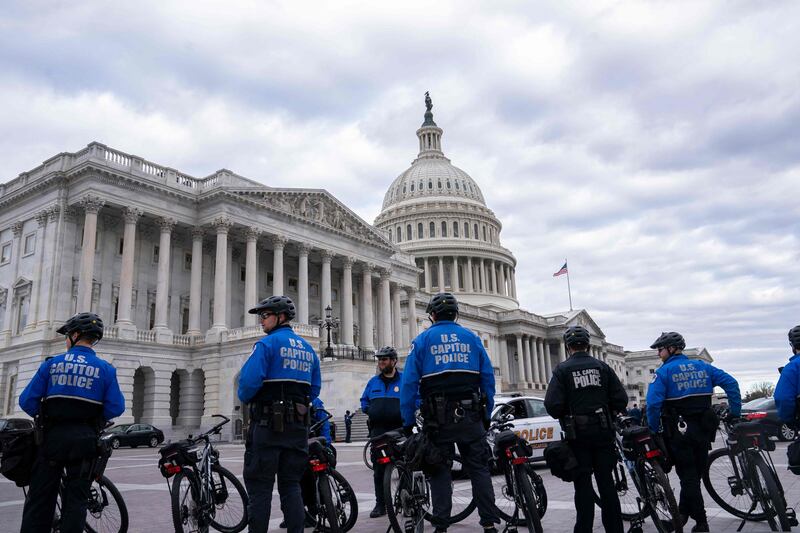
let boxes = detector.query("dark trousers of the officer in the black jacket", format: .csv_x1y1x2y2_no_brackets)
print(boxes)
570,440,623,533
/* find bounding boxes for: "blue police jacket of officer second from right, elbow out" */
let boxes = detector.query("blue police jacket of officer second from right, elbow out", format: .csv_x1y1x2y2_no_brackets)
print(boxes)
647,354,742,432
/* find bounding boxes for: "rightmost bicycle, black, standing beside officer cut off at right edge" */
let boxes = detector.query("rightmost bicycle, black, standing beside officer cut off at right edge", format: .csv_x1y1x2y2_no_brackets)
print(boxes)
703,412,797,531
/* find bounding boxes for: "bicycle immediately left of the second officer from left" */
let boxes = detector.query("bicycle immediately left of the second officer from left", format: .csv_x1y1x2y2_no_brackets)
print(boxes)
158,415,247,533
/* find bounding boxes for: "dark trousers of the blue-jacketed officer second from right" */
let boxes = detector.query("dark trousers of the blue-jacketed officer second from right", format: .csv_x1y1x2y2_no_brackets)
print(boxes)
668,434,708,522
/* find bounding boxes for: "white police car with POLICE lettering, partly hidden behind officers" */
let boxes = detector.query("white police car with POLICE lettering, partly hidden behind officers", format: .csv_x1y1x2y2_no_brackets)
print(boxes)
487,393,561,461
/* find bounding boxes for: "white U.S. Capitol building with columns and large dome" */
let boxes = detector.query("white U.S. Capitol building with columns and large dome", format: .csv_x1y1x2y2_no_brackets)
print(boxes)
0,102,636,433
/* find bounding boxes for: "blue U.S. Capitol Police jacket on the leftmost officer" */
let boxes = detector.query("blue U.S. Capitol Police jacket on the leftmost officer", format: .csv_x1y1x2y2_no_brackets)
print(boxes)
19,346,125,420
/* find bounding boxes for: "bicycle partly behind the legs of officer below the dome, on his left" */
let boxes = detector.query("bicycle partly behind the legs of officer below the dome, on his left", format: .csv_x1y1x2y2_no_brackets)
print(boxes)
370,430,476,533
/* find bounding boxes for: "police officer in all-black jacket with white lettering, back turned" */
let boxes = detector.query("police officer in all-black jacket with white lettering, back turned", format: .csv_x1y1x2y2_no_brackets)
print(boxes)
544,326,628,533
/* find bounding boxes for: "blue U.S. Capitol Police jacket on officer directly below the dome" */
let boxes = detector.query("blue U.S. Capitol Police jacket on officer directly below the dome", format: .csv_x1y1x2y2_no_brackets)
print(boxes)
400,320,494,426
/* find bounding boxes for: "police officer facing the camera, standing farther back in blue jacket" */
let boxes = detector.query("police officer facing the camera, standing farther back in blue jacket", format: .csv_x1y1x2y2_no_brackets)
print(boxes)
361,346,403,518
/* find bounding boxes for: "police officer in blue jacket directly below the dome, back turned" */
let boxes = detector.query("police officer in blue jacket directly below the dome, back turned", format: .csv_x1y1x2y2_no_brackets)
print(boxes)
400,292,500,532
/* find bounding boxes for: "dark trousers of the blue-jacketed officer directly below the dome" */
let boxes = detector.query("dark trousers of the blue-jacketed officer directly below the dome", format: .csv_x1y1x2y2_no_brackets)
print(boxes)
431,415,500,528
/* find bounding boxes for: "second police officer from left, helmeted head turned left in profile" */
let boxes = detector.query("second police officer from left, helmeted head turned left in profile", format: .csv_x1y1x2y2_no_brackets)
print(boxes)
238,296,321,533
